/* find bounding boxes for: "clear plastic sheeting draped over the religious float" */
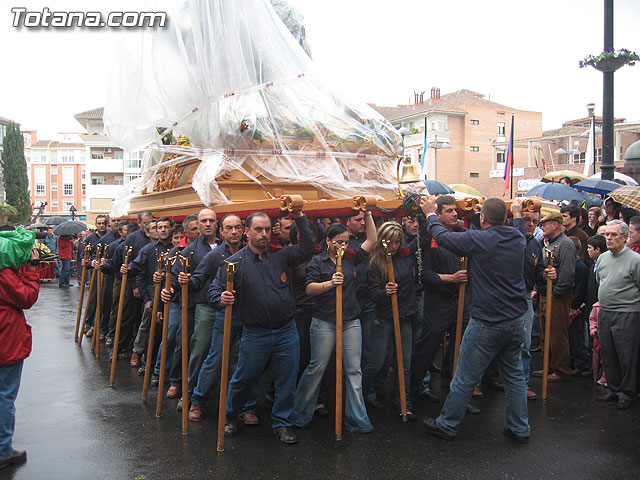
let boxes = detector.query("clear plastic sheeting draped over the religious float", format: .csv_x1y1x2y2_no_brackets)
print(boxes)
104,0,401,214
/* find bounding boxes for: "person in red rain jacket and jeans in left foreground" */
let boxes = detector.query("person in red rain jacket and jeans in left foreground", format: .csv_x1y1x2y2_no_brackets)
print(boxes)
0,240,40,469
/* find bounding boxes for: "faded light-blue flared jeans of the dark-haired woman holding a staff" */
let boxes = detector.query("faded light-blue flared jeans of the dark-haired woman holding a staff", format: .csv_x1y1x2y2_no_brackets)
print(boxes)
293,318,373,433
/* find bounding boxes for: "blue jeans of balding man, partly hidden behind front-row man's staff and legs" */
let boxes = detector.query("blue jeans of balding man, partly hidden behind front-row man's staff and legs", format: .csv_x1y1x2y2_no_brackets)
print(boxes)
191,310,258,413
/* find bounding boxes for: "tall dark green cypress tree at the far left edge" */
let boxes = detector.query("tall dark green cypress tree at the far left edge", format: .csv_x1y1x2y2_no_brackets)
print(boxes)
2,123,31,223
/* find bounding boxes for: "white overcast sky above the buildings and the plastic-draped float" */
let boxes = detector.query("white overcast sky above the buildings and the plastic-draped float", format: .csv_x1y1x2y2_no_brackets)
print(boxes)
0,0,640,139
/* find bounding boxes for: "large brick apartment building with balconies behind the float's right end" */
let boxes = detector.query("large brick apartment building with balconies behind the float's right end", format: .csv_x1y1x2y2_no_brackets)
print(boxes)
371,88,542,196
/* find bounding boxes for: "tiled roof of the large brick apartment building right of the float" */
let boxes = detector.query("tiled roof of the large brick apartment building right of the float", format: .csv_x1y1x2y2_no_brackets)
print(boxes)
369,89,511,121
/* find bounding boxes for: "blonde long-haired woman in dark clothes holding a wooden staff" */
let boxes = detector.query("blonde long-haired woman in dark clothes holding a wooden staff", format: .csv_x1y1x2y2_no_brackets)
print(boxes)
362,222,417,421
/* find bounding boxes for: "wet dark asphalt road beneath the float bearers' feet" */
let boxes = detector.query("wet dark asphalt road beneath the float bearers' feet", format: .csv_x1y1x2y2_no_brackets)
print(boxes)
5,283,640,480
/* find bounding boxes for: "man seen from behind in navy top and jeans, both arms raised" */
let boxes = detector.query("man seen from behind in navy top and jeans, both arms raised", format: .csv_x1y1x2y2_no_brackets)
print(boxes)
420,195,530,443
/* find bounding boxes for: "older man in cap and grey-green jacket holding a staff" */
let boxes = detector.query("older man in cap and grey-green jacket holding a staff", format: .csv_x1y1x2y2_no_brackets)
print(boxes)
533,212,576,382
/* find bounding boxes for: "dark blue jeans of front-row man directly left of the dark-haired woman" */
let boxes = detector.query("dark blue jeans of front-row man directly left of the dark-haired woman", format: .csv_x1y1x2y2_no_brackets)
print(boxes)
226,320,299,429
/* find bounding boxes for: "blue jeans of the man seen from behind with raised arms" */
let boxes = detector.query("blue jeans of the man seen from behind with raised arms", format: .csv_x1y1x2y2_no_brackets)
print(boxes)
436,313,530,437
